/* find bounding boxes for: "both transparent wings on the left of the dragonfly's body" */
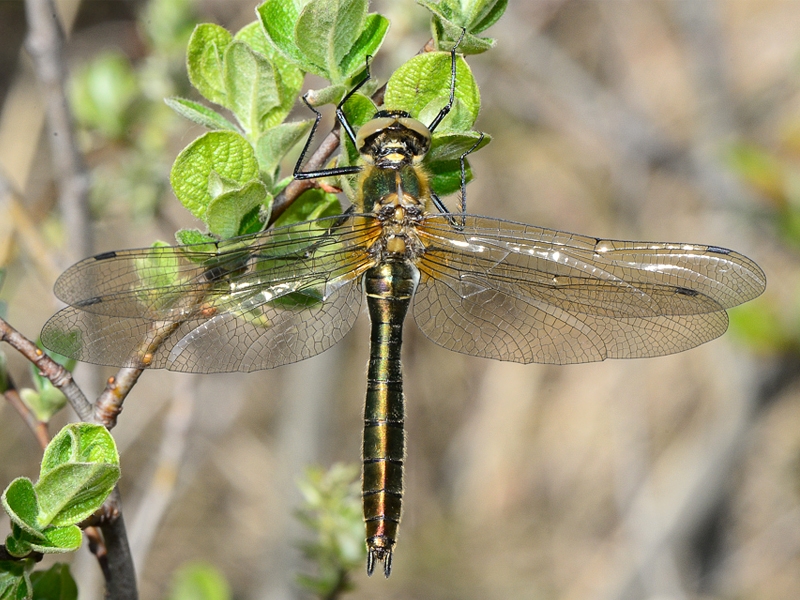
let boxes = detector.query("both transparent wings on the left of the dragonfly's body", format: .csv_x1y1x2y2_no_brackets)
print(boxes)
42,215,380,373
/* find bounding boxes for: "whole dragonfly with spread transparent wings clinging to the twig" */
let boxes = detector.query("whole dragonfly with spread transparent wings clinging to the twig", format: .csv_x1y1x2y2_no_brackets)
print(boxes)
42,34,766,577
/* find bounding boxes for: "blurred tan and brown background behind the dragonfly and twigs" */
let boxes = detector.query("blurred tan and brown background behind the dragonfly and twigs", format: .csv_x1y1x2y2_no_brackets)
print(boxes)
0,0,800,600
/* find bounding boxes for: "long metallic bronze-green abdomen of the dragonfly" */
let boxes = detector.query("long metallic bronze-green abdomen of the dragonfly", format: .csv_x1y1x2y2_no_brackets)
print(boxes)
362,260,419,577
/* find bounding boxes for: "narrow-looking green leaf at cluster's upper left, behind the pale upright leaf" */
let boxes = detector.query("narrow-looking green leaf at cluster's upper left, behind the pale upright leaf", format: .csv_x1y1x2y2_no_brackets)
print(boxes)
186,23,228,107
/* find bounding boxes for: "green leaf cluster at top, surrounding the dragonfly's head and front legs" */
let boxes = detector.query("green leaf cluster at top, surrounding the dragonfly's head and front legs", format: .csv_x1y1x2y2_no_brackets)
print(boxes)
167,0,506,244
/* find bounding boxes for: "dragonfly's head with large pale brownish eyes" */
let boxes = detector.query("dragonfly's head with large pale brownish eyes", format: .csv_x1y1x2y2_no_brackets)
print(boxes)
356,110,431,169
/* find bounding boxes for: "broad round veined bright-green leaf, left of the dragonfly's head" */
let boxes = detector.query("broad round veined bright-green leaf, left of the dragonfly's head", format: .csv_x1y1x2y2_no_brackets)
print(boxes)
170,131,258,219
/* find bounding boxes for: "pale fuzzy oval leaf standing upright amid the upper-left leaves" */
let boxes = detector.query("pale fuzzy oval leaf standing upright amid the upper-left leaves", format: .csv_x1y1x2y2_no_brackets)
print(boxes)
225,41,280,138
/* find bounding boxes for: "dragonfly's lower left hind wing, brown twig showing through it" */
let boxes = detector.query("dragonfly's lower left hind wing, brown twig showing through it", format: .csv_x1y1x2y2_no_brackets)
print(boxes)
42,270,362,373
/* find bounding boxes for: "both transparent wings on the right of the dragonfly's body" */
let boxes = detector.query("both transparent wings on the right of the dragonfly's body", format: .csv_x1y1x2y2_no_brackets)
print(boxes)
414,216,766,364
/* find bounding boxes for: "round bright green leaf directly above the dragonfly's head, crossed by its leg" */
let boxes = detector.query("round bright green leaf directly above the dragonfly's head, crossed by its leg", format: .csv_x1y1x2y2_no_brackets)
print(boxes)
384,52,481,134
